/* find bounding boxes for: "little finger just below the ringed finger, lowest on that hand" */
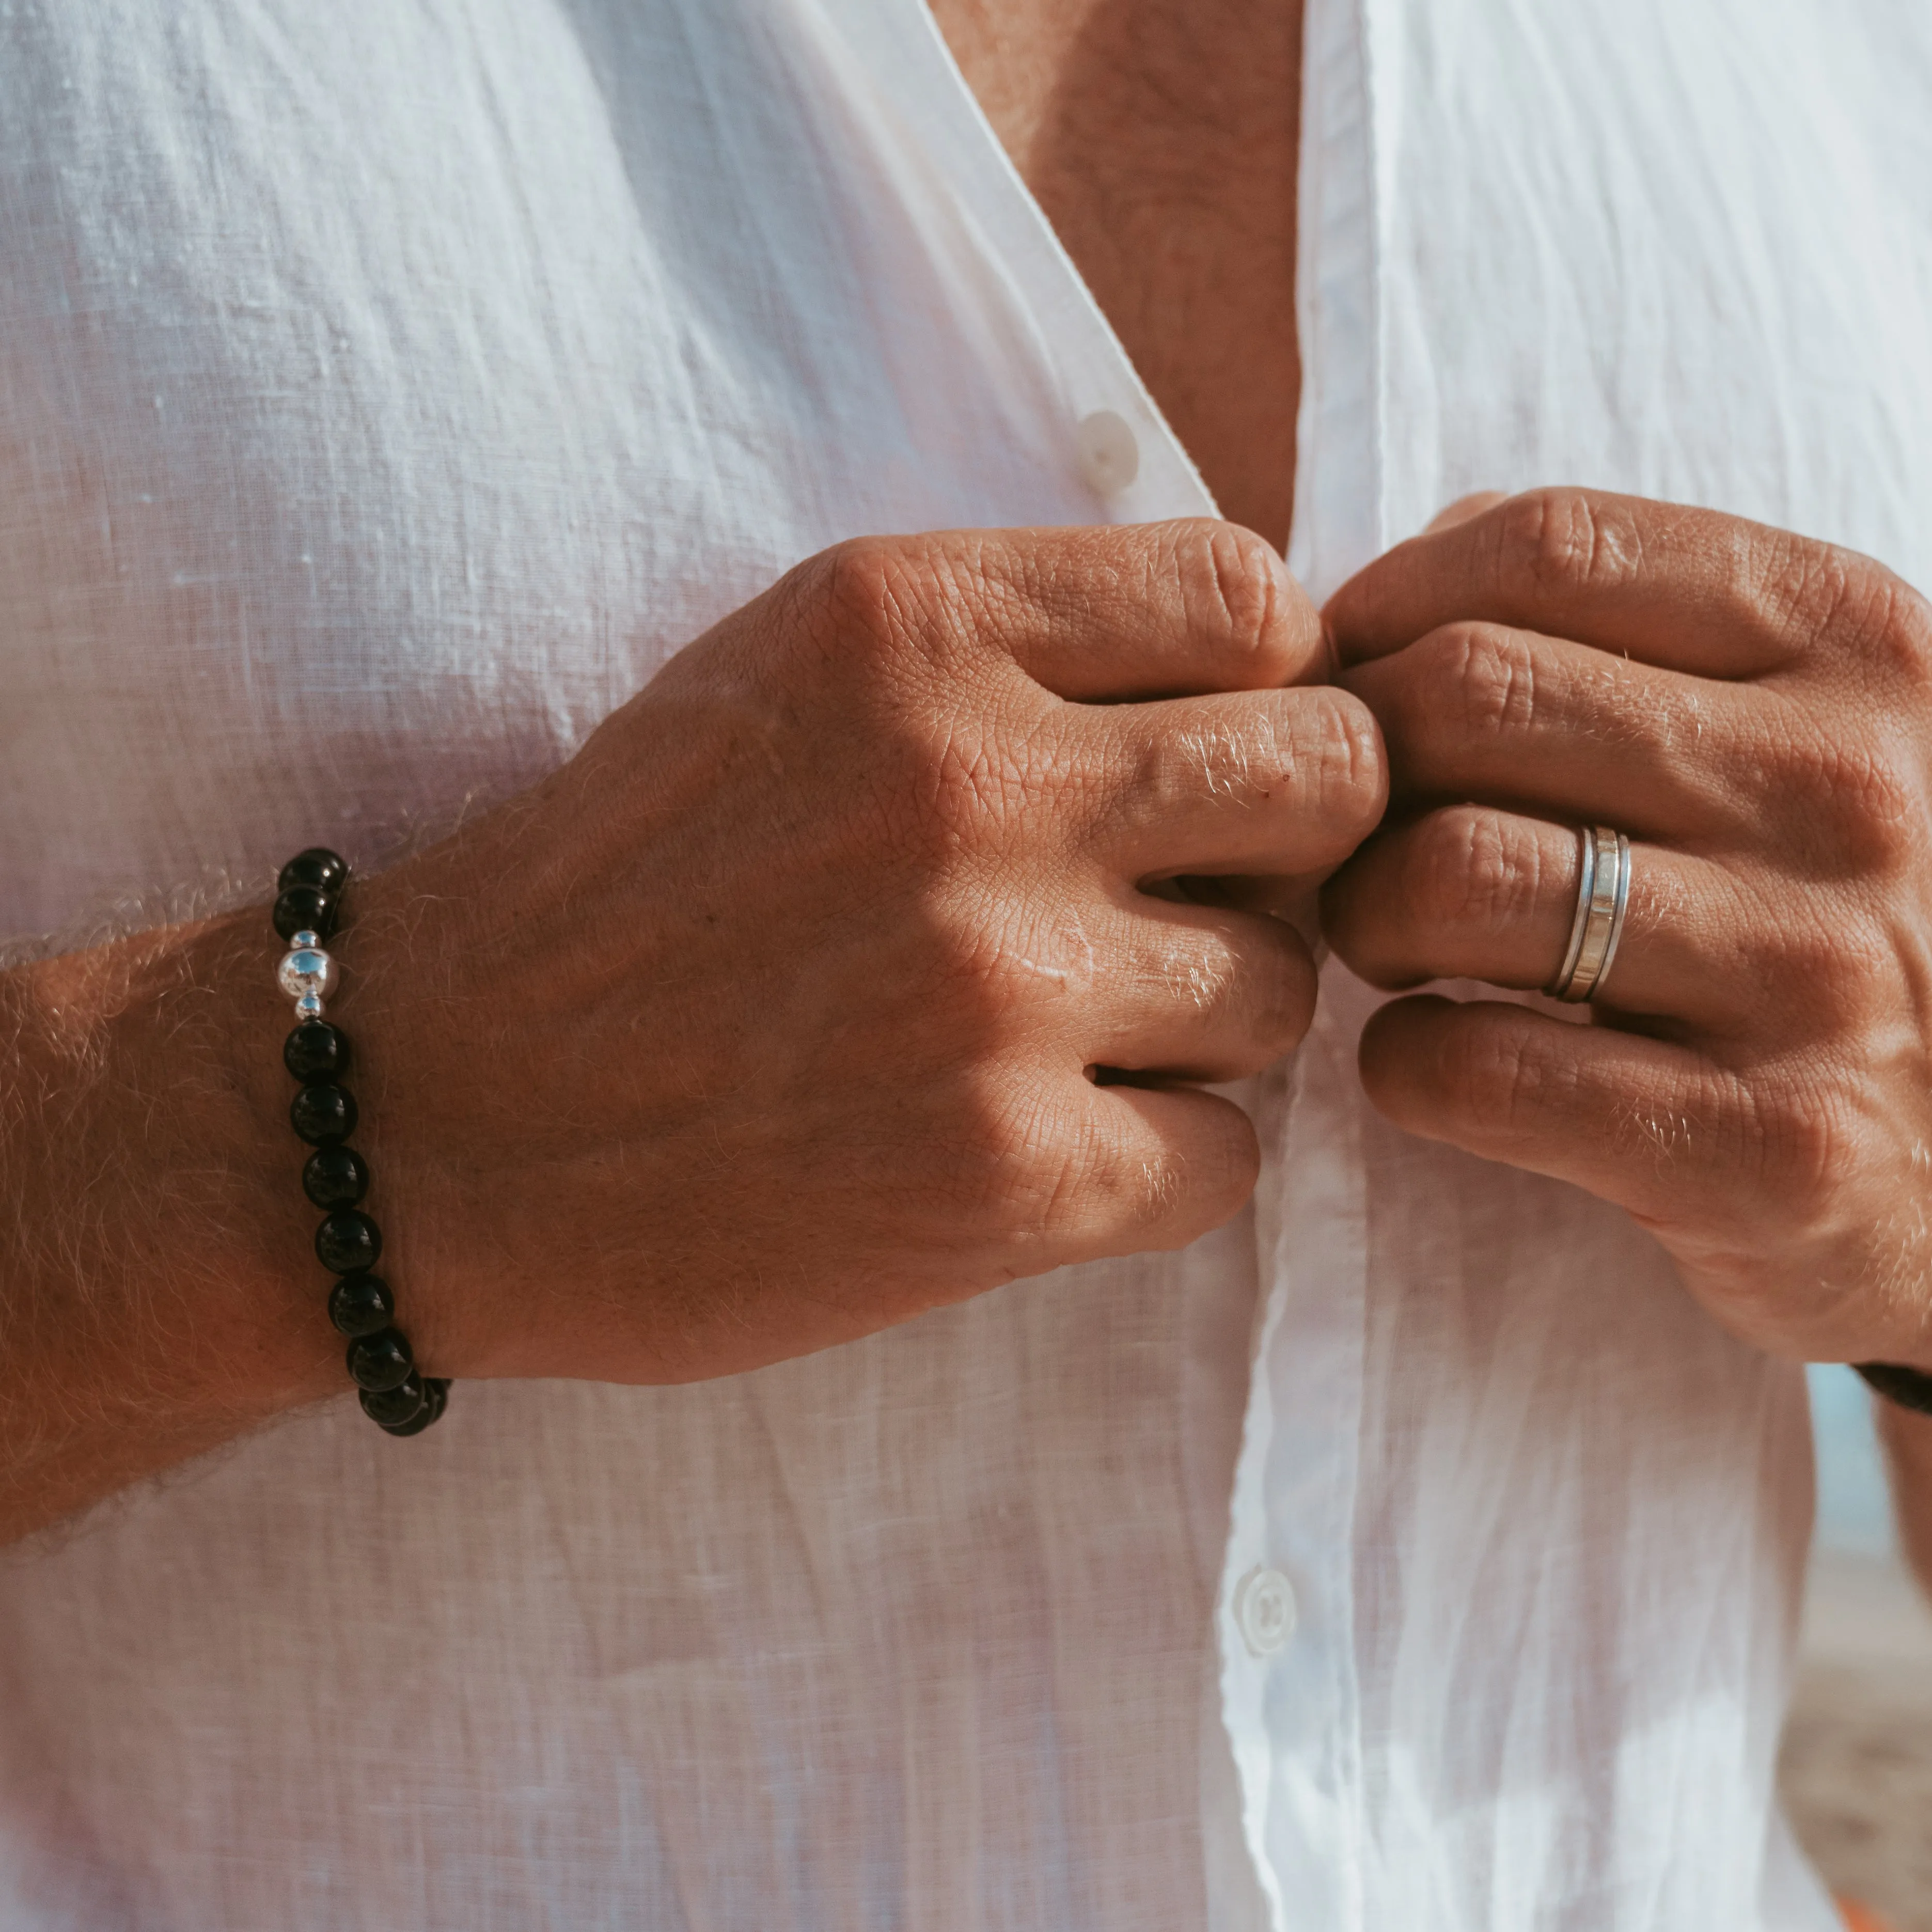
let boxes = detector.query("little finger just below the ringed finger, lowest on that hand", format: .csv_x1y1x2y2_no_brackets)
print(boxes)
1360,993,1749,1221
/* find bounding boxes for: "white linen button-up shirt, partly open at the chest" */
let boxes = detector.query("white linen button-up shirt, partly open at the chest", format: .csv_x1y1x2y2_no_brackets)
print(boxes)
0,0,1932,1932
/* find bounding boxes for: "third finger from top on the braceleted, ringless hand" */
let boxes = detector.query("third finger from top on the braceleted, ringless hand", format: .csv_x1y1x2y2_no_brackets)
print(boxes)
1080,900,1316,1080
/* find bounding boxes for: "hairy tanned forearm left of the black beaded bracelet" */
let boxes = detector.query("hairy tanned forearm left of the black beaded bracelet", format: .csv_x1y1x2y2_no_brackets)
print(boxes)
0,912,340,1540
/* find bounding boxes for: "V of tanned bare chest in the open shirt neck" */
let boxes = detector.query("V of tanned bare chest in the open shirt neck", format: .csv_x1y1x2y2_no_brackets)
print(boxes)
931,0,1302,545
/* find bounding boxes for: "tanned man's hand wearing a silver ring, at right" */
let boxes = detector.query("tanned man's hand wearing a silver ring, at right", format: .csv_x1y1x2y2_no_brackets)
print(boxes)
1324,491,1932,1368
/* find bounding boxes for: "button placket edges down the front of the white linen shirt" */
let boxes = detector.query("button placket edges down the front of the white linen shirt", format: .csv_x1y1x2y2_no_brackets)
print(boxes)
837,0,1381,1932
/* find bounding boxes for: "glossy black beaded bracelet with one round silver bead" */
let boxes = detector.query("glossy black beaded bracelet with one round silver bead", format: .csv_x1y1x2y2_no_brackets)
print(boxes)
274,846,450,1436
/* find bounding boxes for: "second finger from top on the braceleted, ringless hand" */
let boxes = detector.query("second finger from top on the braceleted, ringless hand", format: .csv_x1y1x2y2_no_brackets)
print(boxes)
1069,686,1387,881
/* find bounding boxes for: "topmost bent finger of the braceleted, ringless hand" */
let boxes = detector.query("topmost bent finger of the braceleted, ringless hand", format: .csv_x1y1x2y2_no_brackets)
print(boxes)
935,518,1331,701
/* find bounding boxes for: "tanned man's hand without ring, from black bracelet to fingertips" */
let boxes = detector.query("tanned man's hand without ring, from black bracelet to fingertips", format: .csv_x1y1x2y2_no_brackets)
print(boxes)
359,522,1384,1381
